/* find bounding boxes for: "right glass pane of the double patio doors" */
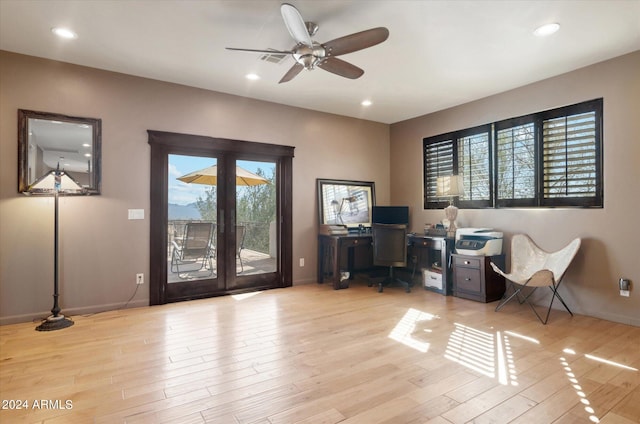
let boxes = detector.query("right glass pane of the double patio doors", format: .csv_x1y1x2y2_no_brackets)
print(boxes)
235,160,278,278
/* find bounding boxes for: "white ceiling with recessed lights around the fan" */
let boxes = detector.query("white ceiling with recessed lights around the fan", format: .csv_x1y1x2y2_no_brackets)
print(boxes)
0,0,640,123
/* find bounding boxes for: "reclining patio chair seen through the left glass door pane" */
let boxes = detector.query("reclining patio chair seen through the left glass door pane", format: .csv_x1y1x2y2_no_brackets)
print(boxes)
171,222,214,278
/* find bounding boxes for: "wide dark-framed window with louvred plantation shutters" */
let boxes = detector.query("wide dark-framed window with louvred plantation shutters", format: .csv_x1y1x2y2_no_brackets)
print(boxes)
423,98,604,209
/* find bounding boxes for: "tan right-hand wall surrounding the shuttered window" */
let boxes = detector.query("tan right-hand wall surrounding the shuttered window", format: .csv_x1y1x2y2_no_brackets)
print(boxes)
391,51,640,325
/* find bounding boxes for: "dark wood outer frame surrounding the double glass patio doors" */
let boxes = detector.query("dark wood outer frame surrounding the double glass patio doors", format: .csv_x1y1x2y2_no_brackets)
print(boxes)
147,130,294,305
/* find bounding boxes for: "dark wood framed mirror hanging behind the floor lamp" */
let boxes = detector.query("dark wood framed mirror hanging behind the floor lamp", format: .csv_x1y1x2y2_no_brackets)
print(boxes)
18,109,102,194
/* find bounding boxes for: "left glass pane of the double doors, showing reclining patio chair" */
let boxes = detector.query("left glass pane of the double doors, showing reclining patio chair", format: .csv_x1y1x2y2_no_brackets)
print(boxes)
167,154,218,284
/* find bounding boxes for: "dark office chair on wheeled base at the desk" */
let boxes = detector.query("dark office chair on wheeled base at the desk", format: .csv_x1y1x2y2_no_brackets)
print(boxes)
369,224,411,293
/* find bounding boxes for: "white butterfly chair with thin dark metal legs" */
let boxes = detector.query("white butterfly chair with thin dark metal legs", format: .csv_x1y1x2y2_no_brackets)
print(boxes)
491,234,580,324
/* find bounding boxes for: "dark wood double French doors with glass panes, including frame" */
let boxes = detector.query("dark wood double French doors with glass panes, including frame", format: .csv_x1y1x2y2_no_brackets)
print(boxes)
149,131,293,304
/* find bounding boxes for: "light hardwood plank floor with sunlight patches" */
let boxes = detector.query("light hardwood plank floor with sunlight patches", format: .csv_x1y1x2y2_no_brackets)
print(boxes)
0,281,640,424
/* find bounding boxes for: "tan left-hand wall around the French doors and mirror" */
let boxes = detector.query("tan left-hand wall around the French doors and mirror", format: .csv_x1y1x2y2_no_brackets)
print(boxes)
0,52,389,323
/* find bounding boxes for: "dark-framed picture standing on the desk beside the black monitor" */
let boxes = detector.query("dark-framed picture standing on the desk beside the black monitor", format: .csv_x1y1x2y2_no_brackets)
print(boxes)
316,178,376,228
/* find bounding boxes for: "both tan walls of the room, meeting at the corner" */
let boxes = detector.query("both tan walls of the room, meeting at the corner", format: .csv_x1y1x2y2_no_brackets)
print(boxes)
0,52,640,325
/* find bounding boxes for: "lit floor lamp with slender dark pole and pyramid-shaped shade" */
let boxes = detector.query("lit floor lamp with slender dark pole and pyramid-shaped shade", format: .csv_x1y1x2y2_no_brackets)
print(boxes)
29,165,83,331
